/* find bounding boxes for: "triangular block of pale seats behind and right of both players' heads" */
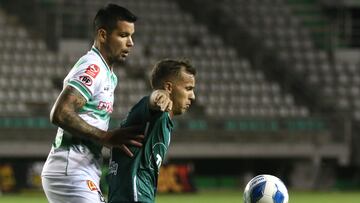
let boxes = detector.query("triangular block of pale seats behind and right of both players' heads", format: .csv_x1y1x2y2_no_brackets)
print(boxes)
111,0,309,117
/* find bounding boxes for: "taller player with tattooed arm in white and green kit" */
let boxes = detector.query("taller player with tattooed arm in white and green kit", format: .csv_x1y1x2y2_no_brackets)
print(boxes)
42,4,172,203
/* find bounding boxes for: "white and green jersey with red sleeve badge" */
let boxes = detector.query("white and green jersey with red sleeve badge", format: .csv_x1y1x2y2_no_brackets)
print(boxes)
42,47,117,188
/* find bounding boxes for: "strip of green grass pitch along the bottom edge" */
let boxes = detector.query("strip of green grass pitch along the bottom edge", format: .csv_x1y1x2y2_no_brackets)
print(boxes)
0,191,360,203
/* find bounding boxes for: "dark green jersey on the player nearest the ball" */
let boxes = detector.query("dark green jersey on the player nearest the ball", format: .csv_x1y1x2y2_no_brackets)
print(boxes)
109,97,173,203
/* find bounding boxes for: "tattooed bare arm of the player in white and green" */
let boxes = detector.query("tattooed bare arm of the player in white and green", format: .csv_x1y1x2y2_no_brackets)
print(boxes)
52,86,105,140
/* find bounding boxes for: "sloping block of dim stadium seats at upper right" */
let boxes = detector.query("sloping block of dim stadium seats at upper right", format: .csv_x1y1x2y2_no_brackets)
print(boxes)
222,0,360,119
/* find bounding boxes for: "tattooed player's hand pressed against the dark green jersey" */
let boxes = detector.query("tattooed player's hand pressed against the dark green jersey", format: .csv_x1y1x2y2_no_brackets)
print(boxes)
103,126,145,157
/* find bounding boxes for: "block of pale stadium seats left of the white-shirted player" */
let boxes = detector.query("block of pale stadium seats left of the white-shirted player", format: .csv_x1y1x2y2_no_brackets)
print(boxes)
0,10,64,116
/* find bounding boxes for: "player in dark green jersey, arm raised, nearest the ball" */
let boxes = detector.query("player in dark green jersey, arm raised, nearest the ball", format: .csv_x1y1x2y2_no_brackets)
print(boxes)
109,59,196,203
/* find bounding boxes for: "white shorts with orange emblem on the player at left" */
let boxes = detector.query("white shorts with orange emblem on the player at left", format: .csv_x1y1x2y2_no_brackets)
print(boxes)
41,176,105,203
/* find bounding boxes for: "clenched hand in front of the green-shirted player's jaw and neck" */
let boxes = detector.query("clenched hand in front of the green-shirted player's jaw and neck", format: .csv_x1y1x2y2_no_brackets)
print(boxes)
150,90,173,111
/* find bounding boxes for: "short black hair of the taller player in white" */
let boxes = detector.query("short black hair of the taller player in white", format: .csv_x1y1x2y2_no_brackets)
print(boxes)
93,4,137,33
